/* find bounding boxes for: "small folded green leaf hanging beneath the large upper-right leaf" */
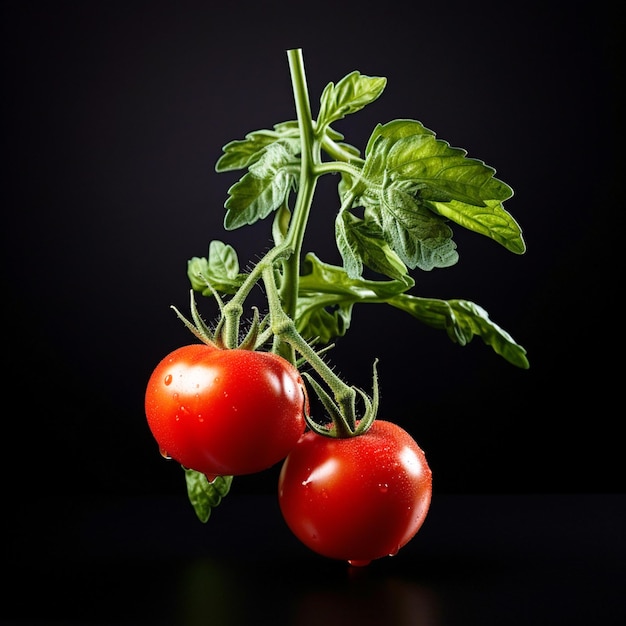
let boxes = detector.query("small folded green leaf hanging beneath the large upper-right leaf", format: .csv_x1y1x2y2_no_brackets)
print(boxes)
335,211,410,284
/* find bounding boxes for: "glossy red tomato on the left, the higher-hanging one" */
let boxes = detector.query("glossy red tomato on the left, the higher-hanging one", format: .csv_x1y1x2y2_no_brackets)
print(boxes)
145,344,308,476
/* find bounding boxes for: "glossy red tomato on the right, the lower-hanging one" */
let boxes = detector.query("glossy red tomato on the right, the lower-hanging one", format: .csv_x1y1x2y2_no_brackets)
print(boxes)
278,420,432,565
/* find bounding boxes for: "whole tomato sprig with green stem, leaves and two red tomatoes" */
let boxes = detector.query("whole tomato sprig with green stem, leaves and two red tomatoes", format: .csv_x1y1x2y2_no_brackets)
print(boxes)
146,49,529,564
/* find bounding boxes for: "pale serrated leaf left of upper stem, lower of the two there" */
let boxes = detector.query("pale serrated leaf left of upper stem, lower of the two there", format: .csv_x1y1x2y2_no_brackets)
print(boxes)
224,140,300,230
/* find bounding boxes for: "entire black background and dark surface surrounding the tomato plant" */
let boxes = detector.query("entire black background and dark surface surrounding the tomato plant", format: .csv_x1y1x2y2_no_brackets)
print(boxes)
0,0,626,626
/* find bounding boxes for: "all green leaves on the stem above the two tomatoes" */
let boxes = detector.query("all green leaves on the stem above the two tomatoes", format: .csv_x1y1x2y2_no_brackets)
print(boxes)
187,71,529,368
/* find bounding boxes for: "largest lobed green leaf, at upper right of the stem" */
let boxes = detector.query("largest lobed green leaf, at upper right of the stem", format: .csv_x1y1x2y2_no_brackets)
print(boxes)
352,120,525,252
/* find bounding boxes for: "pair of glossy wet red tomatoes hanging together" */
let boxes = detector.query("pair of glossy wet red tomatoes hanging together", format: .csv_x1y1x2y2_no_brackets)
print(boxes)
145,344,432,565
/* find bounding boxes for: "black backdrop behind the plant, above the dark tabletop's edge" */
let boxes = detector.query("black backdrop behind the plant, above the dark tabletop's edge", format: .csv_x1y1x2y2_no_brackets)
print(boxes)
1,0,624,502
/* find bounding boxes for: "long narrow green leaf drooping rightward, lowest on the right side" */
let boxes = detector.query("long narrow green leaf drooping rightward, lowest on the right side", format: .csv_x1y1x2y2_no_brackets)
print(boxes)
387,294,529,369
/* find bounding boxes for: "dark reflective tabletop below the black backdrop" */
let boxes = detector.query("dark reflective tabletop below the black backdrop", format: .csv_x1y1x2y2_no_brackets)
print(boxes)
0,494,626,626
